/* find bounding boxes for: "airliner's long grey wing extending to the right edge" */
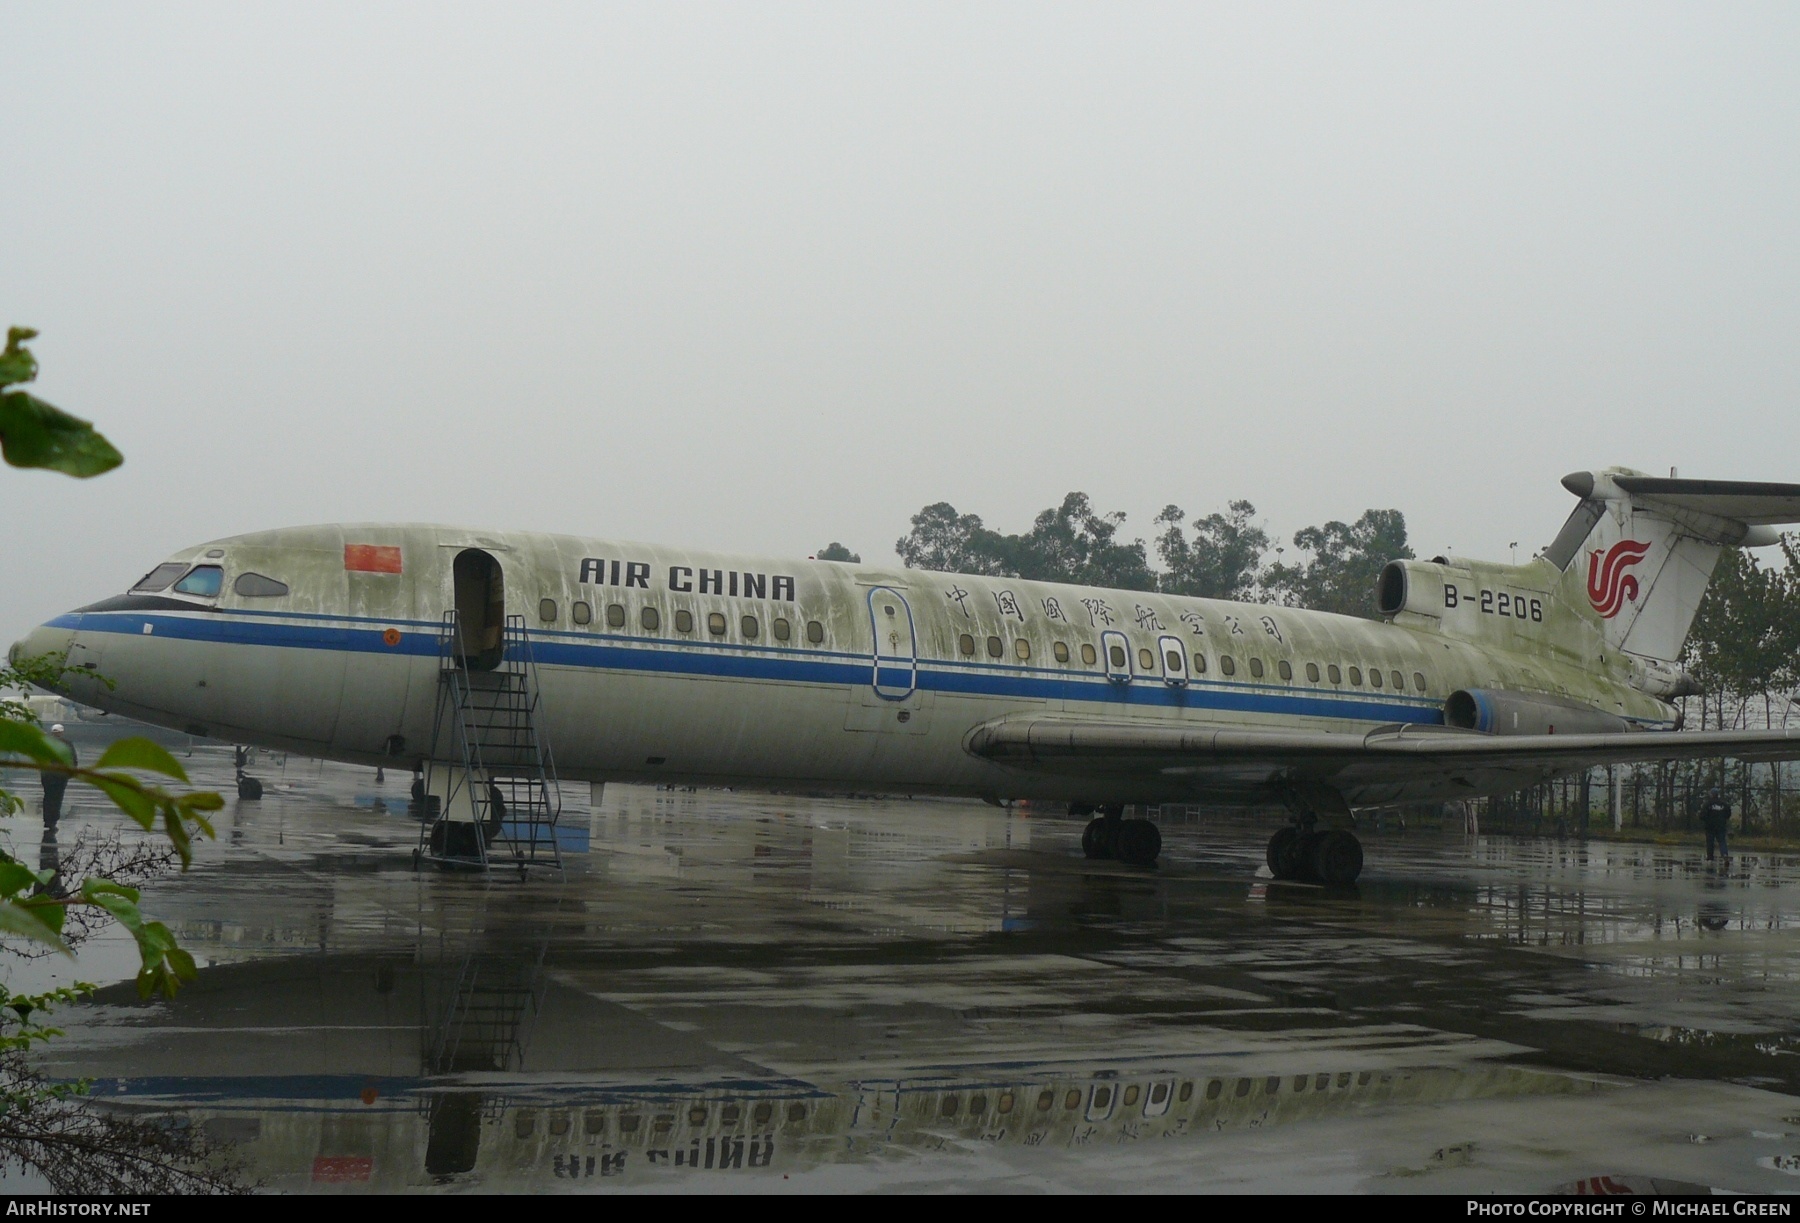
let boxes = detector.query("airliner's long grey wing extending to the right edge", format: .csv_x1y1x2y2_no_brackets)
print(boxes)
967,715,1800,805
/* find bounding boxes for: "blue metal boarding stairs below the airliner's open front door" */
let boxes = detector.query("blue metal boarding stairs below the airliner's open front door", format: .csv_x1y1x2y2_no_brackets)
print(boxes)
414,611,562,874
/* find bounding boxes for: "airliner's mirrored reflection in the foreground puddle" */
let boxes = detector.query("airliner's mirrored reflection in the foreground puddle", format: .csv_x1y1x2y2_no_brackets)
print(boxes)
70,956,1598,1189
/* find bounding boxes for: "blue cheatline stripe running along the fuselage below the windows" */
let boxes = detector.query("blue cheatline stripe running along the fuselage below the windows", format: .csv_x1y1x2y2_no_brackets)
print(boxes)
49,611,1444,724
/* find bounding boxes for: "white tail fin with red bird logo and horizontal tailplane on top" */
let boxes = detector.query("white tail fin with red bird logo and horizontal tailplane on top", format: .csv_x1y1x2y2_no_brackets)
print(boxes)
1543,467,1800,663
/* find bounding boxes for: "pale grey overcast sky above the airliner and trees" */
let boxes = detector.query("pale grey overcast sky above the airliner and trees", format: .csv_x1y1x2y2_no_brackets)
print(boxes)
0,0,1800,645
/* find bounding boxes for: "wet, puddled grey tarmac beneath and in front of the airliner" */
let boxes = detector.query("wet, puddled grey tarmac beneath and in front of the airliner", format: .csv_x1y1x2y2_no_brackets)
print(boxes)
11,726,1800,1192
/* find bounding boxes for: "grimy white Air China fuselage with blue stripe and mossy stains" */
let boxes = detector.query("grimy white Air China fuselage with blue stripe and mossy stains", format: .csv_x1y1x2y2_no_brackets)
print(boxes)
23,526,1674,805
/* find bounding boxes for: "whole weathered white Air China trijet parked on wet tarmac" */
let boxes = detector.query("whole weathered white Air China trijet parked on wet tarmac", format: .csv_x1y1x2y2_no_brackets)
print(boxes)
11,468,1800,884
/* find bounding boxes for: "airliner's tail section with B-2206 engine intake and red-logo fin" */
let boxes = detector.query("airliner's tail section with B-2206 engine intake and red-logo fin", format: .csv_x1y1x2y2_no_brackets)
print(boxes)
1379,467,1800,697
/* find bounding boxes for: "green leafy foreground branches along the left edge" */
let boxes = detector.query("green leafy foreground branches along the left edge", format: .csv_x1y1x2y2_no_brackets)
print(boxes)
0,328,234,1194
